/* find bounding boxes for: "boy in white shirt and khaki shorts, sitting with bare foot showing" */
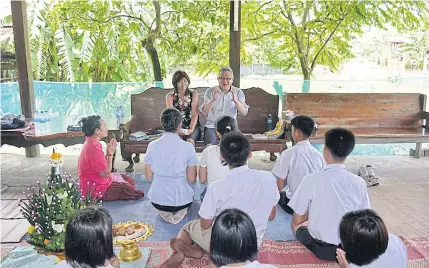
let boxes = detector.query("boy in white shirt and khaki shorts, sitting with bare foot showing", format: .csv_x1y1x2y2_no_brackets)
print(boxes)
160,131,280,267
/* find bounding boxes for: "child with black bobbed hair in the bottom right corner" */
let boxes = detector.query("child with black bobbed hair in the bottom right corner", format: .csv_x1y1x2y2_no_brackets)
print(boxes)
337,209,408,268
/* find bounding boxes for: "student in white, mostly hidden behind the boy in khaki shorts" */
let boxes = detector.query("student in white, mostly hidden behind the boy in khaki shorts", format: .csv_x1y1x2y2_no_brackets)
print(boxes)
198,116,237,196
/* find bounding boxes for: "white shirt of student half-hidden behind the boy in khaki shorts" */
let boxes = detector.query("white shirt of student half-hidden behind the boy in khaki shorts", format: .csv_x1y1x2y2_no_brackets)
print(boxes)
200,145,229,184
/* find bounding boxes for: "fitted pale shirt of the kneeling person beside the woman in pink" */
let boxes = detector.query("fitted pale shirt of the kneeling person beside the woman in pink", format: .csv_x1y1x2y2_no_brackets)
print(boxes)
144,132,198,207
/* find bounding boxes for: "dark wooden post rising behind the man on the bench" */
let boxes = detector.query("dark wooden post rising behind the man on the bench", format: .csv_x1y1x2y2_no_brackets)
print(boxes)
229,0,241,87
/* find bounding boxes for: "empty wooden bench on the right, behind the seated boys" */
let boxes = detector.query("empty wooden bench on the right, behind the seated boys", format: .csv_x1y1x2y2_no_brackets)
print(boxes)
283,93,429,157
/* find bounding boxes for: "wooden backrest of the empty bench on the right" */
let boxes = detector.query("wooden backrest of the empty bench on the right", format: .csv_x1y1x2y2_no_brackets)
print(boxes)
283,93,426,129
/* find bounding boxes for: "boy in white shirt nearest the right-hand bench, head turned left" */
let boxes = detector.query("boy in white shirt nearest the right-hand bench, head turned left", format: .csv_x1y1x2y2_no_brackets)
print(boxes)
271,115,326,215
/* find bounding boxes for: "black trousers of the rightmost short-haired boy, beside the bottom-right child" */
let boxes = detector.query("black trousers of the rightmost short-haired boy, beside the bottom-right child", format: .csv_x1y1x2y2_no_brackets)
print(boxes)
295,226,339,261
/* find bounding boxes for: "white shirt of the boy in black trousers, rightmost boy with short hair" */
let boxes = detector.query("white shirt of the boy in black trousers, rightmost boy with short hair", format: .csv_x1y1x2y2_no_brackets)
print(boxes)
288,164,370,245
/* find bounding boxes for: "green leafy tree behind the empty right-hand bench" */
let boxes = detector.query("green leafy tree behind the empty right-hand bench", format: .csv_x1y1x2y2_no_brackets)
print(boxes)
254,0,429,92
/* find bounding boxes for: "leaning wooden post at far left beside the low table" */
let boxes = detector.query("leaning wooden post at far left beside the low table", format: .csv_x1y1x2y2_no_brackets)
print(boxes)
11,0,39,157
